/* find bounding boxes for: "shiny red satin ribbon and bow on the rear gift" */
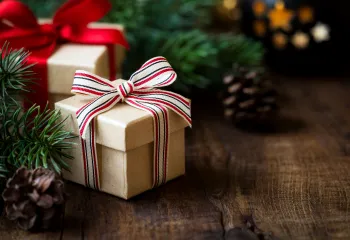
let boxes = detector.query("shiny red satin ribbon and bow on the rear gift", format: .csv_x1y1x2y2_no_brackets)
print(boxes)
0,0,129,106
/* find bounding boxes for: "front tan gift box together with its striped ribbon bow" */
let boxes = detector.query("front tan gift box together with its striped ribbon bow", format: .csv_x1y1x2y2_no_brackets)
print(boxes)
55,57,191,199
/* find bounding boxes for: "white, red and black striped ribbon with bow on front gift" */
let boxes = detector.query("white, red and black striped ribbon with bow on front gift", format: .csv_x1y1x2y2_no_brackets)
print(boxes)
72,57,192,189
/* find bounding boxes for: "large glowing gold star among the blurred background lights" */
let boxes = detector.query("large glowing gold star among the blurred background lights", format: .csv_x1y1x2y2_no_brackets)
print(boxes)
269,1,294,31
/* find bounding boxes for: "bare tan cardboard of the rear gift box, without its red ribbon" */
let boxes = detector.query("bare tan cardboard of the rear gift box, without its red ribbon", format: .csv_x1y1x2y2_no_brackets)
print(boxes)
39,19,125,106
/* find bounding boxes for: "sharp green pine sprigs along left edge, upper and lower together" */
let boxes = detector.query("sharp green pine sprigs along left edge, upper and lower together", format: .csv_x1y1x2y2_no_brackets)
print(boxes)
0,43,73,180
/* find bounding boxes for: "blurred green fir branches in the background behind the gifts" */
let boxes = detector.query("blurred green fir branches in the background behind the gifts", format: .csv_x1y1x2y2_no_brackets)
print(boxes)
104,0,264,93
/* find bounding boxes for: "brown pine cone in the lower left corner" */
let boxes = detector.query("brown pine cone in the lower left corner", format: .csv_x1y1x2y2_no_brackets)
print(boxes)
2,167,66,230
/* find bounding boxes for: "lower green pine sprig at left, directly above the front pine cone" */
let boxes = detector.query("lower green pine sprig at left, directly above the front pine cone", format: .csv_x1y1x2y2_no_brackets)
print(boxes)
0,106,73,173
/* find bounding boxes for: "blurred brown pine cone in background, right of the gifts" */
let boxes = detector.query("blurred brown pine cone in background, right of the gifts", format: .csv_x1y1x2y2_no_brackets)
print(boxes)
223,67,278,123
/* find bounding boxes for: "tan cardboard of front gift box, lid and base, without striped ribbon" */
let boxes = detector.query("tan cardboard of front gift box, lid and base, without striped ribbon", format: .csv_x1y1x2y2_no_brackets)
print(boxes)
55,95,188,199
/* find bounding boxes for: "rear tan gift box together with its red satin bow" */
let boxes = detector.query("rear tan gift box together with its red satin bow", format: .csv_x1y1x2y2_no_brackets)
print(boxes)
0,0,128,106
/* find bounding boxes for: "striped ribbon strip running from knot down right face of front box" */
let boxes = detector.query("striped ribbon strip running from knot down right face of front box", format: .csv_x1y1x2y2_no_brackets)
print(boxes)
126,99,170,187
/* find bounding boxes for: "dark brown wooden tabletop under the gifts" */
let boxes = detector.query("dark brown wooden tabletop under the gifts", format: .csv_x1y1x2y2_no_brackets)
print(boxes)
0,78,350,239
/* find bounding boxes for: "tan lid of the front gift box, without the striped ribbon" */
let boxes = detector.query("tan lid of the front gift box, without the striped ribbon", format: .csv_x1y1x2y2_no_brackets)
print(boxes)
55,95,188,151
